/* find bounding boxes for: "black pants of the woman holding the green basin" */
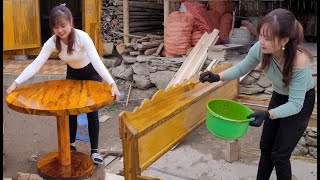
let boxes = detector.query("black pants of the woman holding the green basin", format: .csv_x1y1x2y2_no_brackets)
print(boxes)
257,88,315,180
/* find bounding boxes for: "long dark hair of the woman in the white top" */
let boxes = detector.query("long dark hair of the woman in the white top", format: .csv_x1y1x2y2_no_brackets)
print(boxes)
49,4,75,54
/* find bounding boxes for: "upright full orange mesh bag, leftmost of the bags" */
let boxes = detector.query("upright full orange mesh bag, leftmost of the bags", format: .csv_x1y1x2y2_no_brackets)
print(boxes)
162,11,194,57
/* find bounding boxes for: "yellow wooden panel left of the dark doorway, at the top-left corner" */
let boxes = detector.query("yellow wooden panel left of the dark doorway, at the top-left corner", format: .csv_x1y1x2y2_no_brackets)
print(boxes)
3,0,41,50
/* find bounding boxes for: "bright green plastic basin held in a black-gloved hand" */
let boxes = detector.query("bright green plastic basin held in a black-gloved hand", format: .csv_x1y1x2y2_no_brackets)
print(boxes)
206,99,254,140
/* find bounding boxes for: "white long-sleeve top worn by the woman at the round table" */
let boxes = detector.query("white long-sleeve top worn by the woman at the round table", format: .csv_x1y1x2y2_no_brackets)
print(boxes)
15,29,114,84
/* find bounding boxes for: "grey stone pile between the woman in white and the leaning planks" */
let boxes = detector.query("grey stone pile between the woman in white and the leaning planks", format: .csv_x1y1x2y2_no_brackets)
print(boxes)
107,55,185,89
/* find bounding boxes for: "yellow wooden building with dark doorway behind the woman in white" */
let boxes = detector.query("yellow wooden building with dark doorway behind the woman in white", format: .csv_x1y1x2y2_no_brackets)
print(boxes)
3,0,103,59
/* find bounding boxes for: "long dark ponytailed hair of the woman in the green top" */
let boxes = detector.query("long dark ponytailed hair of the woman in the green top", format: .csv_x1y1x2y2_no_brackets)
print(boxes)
257,8,309,87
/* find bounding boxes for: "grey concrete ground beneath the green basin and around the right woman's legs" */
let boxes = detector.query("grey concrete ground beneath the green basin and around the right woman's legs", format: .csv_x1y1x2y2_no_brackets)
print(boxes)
143,124,317,180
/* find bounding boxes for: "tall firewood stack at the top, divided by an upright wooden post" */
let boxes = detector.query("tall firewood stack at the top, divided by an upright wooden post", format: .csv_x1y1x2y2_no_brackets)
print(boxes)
101,0,163,45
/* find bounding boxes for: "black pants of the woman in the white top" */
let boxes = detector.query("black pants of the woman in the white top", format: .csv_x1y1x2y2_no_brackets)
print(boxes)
66,63,102,149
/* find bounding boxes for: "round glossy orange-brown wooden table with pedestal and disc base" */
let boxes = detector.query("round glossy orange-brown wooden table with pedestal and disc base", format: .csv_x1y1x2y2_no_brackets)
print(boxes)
6,80,115,179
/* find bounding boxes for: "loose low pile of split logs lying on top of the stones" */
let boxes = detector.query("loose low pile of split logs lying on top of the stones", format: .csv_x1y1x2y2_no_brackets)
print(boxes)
116,34,163,56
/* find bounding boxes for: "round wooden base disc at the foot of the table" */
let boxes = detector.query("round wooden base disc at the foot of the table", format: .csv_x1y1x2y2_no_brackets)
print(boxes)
37,151,93,180
